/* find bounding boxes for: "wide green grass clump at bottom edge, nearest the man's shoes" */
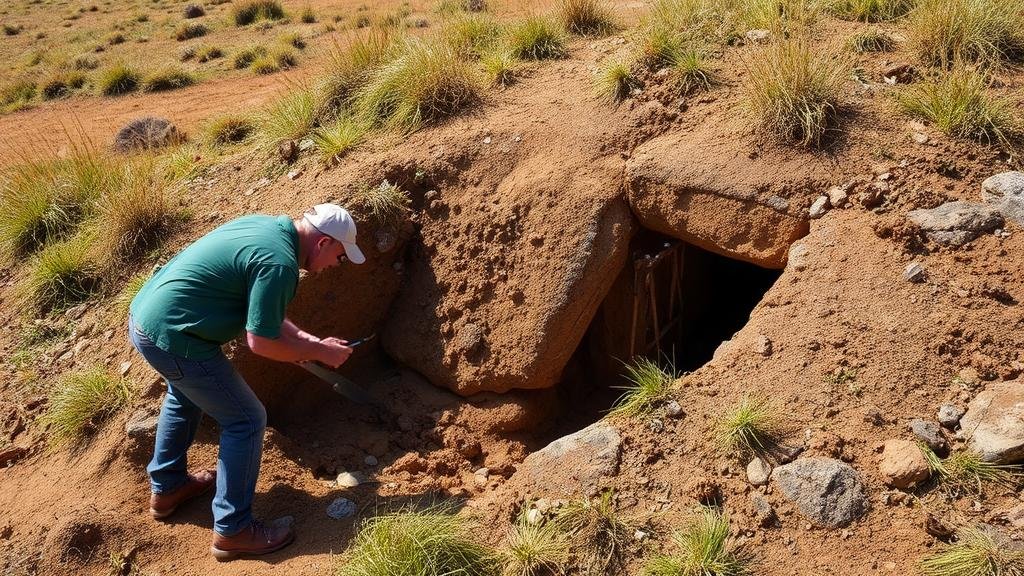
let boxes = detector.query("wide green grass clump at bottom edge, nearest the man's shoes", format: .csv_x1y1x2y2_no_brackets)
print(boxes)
335,506,498,576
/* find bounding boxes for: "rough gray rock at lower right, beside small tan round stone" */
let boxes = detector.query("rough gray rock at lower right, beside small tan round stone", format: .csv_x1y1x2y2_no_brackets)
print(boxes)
772,458,867,528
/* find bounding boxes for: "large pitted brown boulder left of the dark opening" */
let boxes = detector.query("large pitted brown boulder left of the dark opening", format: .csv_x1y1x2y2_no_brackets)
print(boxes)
383,155,634,396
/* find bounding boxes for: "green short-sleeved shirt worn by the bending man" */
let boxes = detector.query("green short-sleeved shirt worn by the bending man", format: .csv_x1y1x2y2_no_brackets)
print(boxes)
131,215,299,360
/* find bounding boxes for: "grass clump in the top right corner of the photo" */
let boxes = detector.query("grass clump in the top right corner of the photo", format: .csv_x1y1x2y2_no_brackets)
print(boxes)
907,0,1024,68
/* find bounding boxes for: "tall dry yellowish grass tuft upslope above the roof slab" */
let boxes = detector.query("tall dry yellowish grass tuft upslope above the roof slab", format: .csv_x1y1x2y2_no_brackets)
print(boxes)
745,35,849,146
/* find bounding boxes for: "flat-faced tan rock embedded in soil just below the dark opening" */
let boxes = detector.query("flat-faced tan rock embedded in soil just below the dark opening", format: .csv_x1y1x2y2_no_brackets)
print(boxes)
516,421,622,494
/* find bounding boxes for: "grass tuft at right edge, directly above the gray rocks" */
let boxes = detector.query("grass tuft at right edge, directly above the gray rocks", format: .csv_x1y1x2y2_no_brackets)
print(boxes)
897,65,1024,145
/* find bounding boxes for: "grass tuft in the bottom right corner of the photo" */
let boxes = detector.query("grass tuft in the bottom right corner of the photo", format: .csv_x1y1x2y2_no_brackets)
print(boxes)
921,528,1024,576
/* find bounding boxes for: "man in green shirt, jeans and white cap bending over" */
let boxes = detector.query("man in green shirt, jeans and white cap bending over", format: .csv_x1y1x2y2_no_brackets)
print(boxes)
128,204,366,561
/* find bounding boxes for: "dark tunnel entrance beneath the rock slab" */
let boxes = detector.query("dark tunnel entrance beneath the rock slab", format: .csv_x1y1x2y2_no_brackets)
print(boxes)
559,231,782,431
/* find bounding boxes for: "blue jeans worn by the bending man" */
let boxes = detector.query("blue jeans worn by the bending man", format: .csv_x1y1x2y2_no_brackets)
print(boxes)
128,318,266,536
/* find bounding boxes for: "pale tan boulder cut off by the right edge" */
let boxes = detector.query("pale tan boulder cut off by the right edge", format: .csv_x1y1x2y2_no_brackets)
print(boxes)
959,380,1024,464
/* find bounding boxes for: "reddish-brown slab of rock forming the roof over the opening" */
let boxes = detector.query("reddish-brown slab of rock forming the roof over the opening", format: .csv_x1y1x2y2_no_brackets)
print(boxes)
626,134,826,269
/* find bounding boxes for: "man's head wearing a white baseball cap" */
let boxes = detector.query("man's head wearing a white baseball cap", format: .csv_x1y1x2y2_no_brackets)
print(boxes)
302,204,367,274
